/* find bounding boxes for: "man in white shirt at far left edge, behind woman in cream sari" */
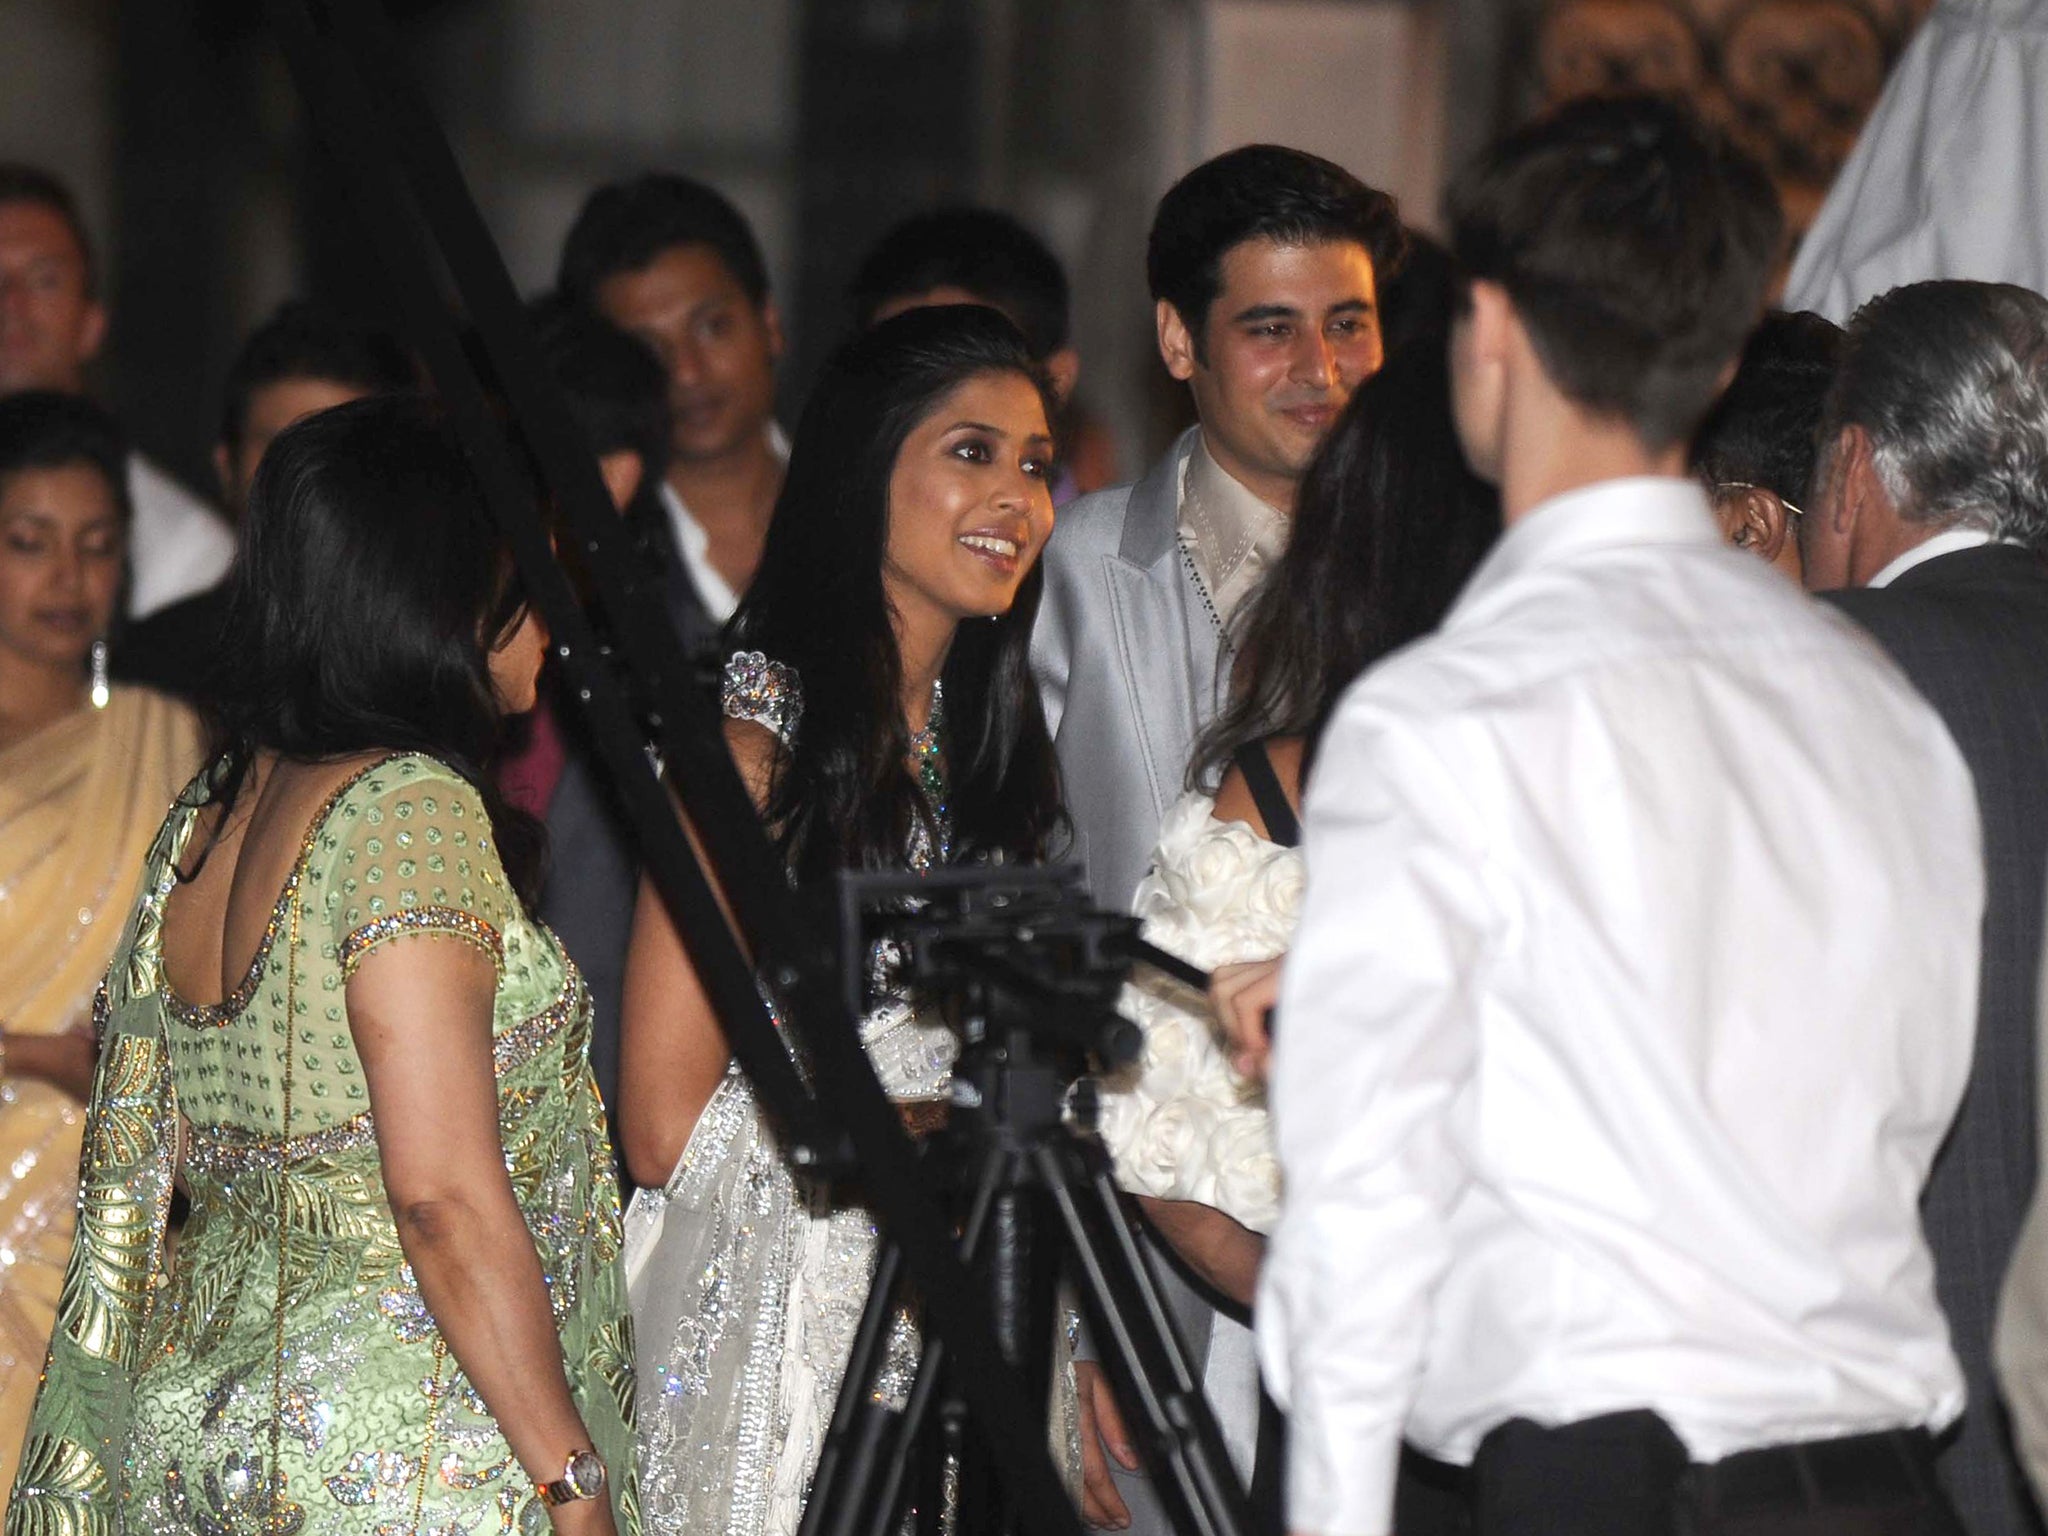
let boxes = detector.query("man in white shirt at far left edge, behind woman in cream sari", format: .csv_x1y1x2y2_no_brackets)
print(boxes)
0,164,236,618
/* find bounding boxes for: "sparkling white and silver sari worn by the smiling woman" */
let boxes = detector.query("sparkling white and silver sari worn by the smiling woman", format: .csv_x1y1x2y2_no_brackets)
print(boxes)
627,653,956,1536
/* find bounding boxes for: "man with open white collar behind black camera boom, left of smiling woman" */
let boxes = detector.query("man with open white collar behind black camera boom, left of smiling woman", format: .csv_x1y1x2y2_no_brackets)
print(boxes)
557,172,788,649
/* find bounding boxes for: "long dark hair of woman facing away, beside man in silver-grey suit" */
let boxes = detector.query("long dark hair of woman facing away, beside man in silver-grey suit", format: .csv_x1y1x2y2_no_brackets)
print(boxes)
1188,336,1501,784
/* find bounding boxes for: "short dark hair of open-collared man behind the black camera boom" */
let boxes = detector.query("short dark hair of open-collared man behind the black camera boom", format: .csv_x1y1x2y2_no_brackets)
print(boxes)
555,170,768,305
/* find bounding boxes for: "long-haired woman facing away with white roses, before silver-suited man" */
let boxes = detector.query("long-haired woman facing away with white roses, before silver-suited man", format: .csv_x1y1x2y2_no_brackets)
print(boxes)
1083,336,1501,1515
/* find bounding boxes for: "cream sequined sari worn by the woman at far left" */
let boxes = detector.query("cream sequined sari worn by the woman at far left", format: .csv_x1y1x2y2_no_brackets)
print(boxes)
0,688,201,1489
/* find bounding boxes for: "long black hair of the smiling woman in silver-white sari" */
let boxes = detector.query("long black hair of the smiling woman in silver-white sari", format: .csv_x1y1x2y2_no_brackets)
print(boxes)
727,305,1063,879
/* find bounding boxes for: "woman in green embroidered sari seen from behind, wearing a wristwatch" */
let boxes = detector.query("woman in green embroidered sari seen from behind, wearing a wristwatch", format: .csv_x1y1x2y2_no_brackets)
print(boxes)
6,399,639,1536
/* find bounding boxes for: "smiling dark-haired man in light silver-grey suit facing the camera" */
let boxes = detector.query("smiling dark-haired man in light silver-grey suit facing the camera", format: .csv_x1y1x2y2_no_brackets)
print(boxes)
1032,145,1405,1530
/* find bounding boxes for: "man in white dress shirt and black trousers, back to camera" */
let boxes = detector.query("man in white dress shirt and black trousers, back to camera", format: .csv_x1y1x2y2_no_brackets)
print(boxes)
1239,100,1985,1536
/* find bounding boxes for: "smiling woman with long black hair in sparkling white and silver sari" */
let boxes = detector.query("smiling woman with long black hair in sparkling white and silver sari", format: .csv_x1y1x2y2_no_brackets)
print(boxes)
621,305,1061,1536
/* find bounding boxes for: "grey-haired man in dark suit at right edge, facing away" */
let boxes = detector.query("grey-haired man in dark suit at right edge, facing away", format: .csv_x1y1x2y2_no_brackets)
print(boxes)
1800,283,2048,1536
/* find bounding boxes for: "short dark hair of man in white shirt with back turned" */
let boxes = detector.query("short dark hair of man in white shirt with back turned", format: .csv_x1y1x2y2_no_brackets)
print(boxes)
1448,96,1784,449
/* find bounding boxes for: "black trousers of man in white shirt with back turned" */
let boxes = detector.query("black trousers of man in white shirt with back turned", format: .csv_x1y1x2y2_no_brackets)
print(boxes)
1397,1411,1964,1536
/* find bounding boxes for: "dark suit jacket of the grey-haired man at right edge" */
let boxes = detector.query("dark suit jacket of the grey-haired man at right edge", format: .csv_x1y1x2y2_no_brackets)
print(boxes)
1827,545,2048,1536
